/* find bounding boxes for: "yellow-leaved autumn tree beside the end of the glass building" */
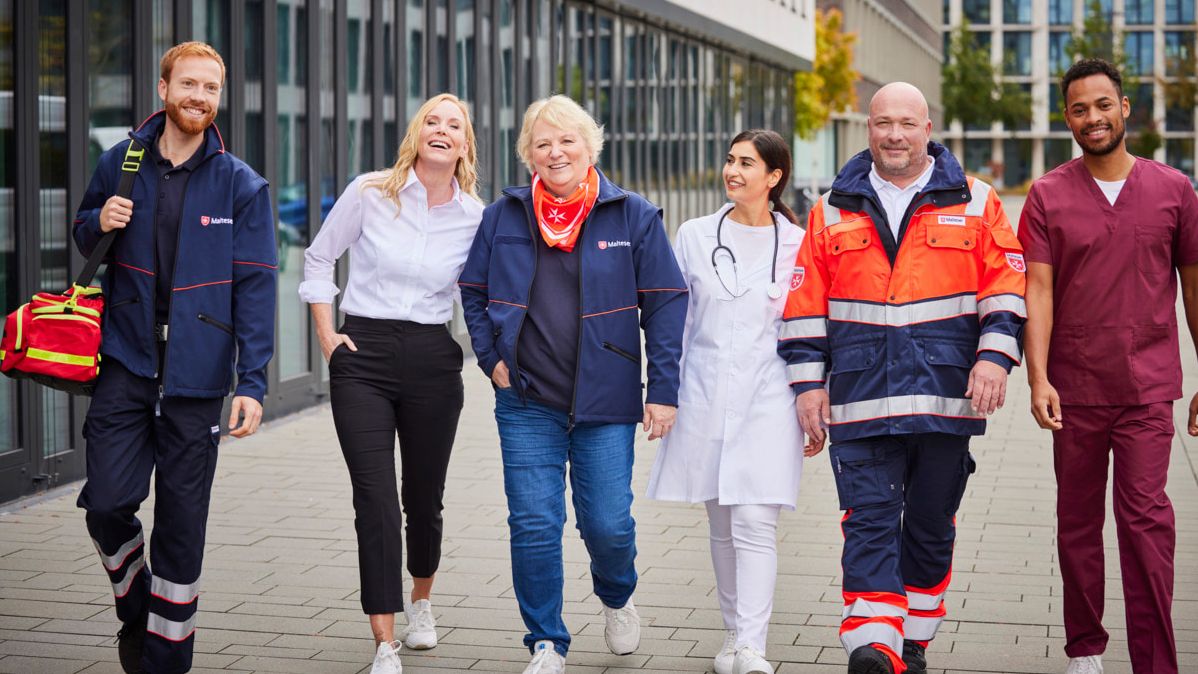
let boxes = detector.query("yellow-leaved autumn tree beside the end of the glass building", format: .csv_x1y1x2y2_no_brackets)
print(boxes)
794,10,860,140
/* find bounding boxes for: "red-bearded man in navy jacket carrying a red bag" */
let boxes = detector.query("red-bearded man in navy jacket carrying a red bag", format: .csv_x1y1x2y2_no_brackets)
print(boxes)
74,42,277,674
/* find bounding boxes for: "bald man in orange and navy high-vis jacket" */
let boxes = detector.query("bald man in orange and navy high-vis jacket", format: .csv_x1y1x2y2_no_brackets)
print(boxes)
778,83,1027,674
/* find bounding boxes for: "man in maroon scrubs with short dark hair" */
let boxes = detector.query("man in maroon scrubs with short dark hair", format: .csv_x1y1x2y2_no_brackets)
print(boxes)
1019,59,1198,674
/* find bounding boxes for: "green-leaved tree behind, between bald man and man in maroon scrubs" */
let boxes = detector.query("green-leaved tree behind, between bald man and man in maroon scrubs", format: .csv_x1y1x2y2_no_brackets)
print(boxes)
940,22,1031,128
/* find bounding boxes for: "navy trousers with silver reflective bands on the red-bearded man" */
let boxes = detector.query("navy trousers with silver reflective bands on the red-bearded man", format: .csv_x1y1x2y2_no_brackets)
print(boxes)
78,358,222,674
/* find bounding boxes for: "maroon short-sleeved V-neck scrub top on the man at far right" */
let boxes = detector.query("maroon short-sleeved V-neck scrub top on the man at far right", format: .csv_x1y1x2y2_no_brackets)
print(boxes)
1018,157,1198,405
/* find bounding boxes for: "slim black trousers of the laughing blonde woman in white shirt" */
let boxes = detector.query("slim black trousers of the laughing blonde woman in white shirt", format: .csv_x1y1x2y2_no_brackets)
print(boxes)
328,316,464,614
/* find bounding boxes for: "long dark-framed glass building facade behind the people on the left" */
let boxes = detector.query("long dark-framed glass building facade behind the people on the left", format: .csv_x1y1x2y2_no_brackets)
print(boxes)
0,0,813,502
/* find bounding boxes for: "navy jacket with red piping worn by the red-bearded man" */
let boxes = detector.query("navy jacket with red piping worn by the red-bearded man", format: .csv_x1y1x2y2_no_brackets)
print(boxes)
74,111,278,401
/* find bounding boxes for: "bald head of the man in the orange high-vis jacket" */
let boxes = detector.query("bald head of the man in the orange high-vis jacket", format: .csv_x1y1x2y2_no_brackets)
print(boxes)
870,81,932,187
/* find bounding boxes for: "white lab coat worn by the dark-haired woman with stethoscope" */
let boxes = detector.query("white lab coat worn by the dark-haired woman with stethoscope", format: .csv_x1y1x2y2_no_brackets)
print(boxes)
648,205,804,509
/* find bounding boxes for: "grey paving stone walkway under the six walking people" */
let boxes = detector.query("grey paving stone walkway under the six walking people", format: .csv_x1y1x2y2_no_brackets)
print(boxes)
0,204,1198,674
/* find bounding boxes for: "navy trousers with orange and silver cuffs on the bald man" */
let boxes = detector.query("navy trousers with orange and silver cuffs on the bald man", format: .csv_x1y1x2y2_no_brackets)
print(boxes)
828,433,975,672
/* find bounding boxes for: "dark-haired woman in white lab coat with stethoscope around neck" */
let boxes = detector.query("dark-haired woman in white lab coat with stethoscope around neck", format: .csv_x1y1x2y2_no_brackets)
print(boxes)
648,129,804,674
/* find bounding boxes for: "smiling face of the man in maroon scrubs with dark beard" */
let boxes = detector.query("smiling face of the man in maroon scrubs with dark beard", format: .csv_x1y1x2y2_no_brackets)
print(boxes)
1065,74,1131,156
